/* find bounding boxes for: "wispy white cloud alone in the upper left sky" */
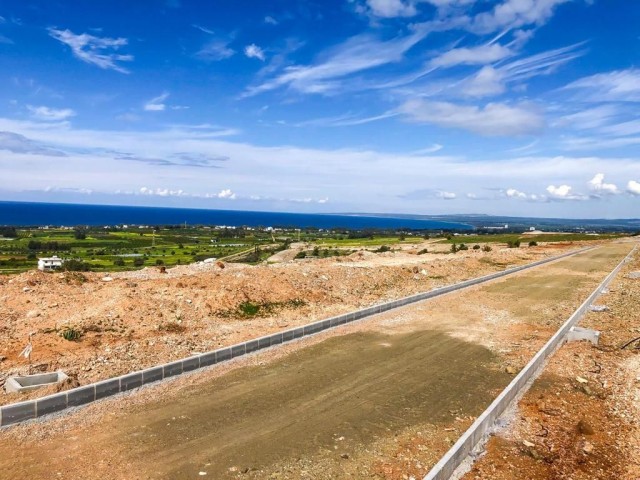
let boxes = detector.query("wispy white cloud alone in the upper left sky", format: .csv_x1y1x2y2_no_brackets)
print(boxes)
49,28,133,73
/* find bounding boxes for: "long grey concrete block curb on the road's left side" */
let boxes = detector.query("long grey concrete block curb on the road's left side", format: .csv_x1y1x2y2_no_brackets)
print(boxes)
0,247,595,427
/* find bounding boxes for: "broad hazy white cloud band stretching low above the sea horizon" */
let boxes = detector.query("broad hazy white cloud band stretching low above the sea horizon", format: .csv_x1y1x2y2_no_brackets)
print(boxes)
0,117,640,218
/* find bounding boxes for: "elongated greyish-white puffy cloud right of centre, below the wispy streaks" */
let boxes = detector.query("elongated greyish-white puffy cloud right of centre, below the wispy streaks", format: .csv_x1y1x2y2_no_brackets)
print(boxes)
399,99,544,136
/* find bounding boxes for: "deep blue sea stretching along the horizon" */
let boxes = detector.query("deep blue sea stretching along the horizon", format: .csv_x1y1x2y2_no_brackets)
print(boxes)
0,201,473,230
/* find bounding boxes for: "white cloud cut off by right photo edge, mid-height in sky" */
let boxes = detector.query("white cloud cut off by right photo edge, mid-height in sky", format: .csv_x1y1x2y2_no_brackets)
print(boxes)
565,68,640,102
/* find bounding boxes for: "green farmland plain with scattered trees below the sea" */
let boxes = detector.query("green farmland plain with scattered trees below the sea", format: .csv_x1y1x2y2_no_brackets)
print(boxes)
0,226,623,273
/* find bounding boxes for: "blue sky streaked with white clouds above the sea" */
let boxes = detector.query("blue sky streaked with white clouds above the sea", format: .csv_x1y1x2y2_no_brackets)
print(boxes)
0,0,640,218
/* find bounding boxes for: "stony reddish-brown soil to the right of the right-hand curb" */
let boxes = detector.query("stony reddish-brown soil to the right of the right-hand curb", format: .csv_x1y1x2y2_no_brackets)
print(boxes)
464,244,640,480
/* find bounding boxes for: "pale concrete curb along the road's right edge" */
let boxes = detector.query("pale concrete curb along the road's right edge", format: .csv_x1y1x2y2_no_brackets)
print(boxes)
423,245,638,480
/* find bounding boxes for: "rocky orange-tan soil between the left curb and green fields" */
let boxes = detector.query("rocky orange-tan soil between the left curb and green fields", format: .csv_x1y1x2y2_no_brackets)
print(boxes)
0,240,579,404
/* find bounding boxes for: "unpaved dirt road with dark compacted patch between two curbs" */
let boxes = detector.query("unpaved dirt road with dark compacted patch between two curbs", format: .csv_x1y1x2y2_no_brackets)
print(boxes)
0,244,631,479
